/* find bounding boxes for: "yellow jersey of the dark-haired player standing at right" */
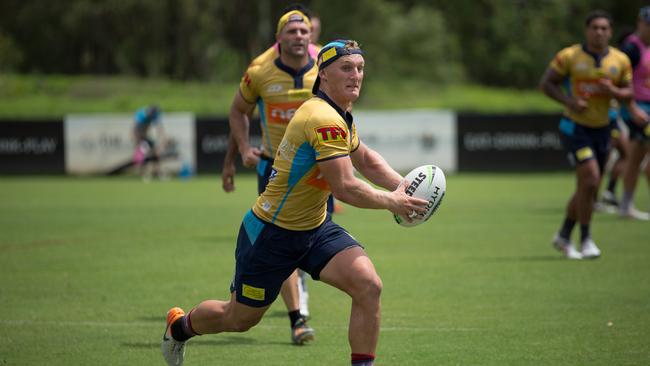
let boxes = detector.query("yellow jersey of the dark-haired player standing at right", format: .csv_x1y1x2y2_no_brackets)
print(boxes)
550,44,632,128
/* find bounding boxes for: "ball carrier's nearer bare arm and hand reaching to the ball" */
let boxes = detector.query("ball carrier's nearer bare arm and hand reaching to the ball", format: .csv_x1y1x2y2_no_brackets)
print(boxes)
318,156,428,216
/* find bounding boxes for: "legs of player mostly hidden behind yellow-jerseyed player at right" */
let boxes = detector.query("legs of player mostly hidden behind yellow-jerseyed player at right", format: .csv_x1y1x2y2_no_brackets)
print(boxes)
594,101,629,213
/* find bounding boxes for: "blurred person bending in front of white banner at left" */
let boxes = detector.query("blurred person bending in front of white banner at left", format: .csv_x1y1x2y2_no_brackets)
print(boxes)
133,105,165,179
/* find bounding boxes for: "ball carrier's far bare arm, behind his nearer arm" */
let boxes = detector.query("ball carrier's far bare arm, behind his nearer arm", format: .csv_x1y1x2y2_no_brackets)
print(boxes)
350,142,402,191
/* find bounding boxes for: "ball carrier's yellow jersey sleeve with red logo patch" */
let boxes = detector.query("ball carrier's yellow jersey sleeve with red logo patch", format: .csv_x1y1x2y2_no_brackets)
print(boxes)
305,116,351,161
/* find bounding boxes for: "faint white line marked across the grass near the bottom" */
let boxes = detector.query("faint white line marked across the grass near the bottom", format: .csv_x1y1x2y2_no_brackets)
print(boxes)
0,318,482,332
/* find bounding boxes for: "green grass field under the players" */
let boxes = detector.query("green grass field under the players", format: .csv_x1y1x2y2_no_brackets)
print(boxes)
0,174,650,366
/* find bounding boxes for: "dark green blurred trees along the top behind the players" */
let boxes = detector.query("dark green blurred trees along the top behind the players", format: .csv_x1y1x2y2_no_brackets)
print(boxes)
0,0,645,88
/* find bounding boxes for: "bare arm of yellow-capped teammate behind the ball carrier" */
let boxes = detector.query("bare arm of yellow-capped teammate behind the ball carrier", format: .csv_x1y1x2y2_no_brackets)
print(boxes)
228,90,261,168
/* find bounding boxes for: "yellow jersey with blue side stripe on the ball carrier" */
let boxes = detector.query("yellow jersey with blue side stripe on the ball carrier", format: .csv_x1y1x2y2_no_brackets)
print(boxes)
253,91,360,231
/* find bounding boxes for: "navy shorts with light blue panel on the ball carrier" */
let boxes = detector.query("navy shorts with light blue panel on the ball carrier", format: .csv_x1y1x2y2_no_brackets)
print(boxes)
230,211,361,307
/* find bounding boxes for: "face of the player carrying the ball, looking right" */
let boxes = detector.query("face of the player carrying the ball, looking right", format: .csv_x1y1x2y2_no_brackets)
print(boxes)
322,55,364,103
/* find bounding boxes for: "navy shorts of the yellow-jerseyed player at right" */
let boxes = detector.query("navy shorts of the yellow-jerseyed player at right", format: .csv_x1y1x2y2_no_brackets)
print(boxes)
560,117,611,171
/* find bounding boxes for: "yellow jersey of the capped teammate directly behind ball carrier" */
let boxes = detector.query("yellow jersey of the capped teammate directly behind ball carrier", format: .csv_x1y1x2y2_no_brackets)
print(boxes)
239,57,318,157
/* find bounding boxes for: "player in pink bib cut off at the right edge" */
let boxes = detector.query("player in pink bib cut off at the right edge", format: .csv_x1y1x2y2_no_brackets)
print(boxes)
620,6,650,220
